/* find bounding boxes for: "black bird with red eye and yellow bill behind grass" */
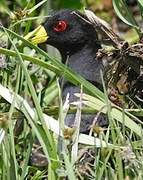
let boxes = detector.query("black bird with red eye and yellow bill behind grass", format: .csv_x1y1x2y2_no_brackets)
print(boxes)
32,9,107,133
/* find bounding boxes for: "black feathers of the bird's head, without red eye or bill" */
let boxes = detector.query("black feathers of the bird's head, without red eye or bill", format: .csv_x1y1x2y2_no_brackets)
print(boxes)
44,10,100,60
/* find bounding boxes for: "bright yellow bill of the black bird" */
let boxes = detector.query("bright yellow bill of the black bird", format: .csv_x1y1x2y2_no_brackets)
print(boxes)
24,25,48,44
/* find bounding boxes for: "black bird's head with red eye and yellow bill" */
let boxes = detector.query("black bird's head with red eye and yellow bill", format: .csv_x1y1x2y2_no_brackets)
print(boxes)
32,10,97,51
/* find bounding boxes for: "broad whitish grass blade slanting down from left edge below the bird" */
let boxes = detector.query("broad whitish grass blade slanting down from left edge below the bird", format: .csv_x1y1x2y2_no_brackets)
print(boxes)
0,84,110,147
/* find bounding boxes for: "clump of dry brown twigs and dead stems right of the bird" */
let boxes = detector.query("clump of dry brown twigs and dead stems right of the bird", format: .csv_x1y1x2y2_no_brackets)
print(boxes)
82,10,143,108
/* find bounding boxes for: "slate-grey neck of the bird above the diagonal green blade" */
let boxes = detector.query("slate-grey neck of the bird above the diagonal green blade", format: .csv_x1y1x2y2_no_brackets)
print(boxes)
62,43,103,83
